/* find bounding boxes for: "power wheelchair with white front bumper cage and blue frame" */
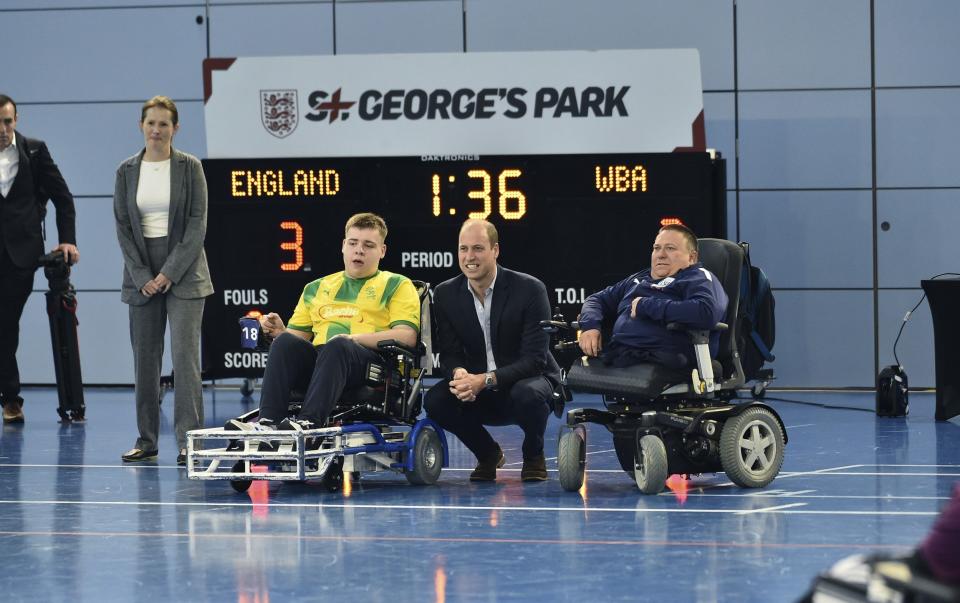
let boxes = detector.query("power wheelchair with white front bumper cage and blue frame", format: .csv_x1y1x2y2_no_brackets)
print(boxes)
187,281,449,492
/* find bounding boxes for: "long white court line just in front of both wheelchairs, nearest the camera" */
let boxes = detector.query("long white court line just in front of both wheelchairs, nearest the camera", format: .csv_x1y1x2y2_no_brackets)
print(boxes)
0,500,940,517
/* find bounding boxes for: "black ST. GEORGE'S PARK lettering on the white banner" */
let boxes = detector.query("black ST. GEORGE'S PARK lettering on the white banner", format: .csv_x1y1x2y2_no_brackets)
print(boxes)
306,86,630,122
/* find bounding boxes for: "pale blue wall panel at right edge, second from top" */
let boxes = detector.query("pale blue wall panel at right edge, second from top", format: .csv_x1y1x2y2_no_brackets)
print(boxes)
877,89,960,187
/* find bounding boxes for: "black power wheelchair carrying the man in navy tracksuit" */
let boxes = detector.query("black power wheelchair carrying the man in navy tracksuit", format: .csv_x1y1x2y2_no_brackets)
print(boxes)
541,239,787,494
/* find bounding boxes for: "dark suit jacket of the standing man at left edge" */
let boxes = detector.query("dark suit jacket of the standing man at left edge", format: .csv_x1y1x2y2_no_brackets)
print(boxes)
0,132,77,268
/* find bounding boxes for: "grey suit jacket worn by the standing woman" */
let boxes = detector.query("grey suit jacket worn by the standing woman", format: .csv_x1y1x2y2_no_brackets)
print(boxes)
113,149,213,306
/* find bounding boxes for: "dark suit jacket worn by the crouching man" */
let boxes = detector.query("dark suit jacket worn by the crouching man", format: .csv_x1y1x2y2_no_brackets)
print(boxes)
433,266,560,390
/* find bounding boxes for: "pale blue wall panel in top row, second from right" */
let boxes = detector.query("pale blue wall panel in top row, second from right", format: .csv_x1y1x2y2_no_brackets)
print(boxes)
737,0,870,89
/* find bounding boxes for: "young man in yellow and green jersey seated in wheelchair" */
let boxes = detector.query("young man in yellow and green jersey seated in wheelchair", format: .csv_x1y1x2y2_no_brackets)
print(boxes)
226,213,420,431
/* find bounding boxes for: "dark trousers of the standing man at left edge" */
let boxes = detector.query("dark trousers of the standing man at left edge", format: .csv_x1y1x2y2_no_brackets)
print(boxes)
0,245,35,403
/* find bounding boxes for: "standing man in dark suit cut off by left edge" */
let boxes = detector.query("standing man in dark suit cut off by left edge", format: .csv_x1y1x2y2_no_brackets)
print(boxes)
0,94,80,423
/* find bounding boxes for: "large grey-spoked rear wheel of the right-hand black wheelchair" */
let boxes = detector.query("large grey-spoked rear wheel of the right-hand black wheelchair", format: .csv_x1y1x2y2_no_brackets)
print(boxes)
720,406,784,488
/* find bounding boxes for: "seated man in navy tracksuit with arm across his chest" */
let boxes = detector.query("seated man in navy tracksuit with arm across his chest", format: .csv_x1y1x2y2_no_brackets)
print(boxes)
579,225,728,369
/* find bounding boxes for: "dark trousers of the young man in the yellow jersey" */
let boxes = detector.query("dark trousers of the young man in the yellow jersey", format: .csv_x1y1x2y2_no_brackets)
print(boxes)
260,333,381,424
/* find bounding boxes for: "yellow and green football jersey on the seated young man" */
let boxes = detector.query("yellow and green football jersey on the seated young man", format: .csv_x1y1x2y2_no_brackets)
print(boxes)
287,270,420,345
